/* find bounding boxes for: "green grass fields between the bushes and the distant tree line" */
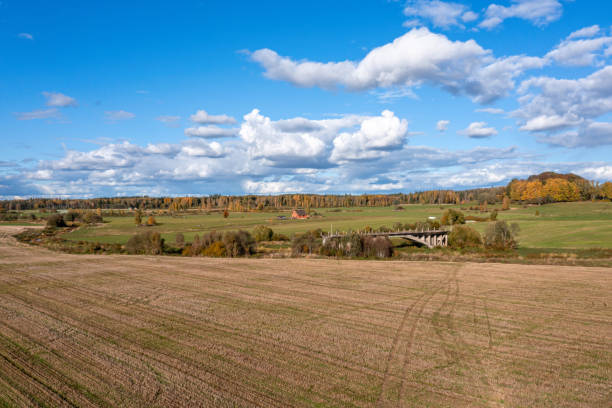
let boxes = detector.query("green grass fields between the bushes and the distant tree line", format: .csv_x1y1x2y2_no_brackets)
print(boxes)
59,202,612,249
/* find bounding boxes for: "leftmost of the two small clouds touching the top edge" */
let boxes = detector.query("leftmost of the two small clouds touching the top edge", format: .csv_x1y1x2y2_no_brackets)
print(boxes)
404,0,478,28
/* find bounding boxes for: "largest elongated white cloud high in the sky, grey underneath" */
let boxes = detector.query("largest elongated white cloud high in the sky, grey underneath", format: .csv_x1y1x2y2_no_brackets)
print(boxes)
251,27,546,103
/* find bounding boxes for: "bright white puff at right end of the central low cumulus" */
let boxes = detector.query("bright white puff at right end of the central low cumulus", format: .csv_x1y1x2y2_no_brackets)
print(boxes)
330,110,408,163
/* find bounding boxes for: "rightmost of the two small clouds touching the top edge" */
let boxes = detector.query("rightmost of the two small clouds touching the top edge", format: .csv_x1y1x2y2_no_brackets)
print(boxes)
479,0,563,29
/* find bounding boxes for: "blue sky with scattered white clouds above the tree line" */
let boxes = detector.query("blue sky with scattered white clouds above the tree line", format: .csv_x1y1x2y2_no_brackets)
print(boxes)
0,0,612,198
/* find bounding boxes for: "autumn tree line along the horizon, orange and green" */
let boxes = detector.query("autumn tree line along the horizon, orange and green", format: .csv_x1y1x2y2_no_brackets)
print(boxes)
0,172,612,212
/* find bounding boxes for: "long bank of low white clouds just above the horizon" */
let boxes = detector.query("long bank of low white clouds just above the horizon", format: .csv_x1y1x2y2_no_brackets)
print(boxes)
5,105,610,197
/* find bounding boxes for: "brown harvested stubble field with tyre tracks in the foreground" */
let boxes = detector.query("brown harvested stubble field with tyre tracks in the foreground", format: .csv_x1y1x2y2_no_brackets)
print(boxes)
0,228,612,407
